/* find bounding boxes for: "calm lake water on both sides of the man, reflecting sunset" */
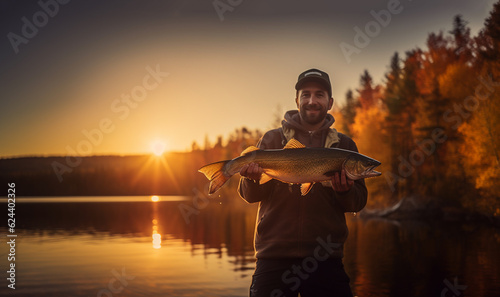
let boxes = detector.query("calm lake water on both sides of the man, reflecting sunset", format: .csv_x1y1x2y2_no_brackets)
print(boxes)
0,196,500,297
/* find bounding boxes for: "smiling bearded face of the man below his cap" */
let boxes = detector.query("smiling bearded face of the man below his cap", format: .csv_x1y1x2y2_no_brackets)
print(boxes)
296,82,333,125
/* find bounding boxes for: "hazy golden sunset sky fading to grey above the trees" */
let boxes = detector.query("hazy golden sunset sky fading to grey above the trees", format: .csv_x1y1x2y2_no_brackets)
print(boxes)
0,0,495,158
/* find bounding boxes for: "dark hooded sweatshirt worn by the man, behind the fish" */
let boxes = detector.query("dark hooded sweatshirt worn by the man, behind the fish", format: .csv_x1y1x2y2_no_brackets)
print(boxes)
238,110,367,259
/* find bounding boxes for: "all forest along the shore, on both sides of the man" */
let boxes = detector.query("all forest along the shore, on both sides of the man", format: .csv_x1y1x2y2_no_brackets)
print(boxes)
0,2,500,216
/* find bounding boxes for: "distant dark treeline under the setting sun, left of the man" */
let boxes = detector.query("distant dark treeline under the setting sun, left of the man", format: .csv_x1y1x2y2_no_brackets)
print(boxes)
0,128,261,196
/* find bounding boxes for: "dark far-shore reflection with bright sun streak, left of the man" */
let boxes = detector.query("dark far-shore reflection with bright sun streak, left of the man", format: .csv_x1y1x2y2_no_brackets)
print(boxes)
10,196,257,275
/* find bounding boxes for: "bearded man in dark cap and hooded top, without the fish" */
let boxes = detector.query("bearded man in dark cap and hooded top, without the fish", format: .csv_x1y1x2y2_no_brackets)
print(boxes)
238,69,367,297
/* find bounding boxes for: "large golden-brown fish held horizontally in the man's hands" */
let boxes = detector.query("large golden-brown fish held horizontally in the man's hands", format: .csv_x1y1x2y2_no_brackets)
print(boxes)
199,139,381,196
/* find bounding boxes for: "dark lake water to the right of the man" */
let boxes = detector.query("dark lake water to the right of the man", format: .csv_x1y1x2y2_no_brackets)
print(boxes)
344,215,500,297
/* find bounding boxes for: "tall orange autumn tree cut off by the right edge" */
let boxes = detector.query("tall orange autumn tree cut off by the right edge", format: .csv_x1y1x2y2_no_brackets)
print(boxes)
458,1,500,215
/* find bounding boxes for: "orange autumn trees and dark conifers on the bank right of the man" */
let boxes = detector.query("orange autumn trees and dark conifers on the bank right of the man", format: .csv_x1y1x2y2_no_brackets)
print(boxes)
334,2,500,215
